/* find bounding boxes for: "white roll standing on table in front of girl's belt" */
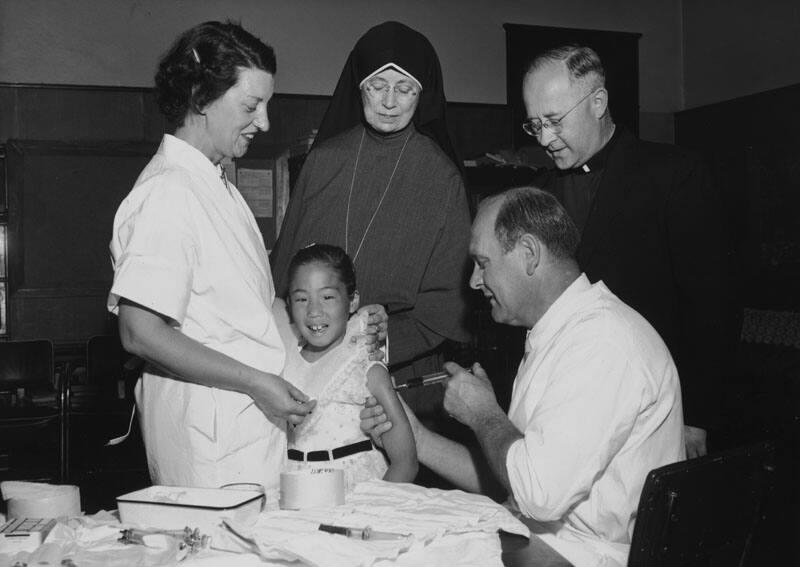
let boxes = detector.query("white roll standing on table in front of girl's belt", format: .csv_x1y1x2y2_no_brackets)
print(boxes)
280,468,344,510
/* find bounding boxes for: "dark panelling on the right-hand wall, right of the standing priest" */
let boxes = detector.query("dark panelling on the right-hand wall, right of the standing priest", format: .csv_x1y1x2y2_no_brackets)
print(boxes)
675,85,800,311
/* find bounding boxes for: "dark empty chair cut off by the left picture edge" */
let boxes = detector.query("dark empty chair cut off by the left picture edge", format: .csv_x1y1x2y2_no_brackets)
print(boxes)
0,339,66,482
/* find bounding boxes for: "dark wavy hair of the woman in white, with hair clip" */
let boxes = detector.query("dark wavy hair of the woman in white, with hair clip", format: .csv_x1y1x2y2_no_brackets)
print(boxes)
155,21,277,126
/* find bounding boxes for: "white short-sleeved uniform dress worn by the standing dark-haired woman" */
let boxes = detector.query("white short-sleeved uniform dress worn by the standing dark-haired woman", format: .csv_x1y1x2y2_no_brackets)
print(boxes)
108,135,286,491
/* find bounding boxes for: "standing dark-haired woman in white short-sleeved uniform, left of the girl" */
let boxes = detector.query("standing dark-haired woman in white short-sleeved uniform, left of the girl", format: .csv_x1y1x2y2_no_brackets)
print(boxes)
108,22,385,491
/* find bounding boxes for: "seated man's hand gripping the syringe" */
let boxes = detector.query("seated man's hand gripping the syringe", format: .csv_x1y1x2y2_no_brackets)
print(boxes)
444,362,505,430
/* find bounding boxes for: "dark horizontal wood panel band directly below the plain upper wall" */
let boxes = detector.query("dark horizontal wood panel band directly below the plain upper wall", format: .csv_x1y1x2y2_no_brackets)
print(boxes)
0,83,513,159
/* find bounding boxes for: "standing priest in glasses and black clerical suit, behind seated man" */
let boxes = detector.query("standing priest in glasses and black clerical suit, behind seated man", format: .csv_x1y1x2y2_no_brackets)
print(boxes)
522,45,740,458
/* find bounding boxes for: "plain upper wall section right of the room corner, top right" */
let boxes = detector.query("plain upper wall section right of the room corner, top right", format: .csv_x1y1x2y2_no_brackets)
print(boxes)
683,0,800,108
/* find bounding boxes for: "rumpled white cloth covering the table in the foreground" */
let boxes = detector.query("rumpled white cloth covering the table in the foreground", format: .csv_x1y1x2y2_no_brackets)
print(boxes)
0,480,530,567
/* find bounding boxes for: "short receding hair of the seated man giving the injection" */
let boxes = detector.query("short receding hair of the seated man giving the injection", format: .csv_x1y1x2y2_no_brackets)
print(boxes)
494,187,580,259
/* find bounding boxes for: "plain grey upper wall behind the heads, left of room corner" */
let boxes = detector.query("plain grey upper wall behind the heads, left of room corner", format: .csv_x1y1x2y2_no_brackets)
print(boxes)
0,0,682,113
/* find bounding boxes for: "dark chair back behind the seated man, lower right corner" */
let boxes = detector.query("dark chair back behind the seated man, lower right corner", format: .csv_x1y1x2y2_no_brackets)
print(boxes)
628,442,775,567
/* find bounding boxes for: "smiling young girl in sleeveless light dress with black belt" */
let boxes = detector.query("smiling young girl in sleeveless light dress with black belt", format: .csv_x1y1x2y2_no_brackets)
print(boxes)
284,244,418,492
